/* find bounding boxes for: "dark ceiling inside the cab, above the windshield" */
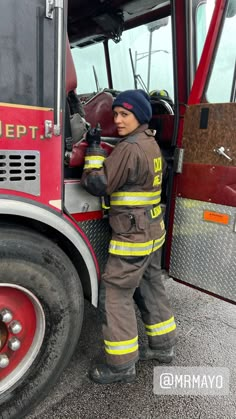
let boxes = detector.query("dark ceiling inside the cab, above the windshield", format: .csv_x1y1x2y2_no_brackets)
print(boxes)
68,0,170,47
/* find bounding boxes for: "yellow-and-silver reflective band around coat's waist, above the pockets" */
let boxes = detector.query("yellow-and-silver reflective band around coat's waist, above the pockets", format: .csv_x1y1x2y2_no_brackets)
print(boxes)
111,191,161,206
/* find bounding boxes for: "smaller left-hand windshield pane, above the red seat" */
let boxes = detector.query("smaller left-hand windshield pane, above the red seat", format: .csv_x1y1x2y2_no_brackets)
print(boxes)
71,43,108,94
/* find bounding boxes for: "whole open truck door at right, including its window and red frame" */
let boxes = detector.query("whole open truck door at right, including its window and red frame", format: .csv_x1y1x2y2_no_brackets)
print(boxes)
169,1,236,303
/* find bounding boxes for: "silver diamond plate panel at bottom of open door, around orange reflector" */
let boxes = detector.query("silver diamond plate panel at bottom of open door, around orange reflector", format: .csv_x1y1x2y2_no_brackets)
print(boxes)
169,198,236,301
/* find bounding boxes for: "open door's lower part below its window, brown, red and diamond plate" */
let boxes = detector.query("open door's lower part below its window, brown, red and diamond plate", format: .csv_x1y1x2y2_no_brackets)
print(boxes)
170,103,236,301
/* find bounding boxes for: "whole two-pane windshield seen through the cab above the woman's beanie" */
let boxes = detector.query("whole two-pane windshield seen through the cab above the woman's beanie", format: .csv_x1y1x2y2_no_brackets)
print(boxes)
72,17,174,99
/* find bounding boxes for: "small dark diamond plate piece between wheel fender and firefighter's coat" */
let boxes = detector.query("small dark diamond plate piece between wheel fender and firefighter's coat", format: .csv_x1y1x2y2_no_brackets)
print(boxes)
78,218,111,273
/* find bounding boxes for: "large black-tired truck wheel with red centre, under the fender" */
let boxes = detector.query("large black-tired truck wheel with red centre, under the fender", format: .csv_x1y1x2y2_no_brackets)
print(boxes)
0,225,84,419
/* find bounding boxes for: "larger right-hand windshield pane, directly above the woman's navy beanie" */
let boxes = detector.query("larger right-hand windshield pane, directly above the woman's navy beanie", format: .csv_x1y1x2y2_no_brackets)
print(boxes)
109,17,174,98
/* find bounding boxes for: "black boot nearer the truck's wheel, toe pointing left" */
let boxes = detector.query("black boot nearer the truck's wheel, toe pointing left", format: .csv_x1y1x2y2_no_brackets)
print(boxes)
89,364,136,384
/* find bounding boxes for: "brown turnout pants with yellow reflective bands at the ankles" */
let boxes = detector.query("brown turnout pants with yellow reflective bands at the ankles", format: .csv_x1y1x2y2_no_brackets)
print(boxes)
99,249,176,369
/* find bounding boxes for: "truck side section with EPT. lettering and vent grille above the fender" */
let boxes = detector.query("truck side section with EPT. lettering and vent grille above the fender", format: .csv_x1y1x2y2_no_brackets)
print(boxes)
0,0,65,209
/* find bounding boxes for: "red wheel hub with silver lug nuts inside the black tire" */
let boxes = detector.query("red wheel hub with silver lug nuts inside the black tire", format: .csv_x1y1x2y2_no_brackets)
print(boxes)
0,283,45,394
